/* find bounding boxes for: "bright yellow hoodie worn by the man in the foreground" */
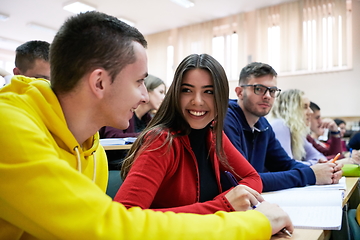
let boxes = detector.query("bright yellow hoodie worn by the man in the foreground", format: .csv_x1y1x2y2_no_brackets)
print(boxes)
0,76,271,240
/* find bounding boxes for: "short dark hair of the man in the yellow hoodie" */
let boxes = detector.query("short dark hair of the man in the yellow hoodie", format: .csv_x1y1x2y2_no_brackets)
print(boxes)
50,11,147,93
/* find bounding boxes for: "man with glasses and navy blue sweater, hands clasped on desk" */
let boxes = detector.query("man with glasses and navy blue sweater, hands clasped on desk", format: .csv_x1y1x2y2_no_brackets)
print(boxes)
224,62,332,192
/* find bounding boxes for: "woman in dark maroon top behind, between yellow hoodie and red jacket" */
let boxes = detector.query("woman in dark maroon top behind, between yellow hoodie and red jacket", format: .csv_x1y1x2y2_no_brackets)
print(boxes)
99,75,166,138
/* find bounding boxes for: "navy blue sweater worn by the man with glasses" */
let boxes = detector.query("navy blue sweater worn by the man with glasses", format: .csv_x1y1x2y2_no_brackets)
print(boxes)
224,99,316,192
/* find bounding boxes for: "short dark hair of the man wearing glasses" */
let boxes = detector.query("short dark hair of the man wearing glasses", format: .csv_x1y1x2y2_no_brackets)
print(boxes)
239,62,277,85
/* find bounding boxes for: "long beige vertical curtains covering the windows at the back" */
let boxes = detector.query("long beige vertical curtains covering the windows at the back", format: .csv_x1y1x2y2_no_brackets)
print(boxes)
146,0,352,82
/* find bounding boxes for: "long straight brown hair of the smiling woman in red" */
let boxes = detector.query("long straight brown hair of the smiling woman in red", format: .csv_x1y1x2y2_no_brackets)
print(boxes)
121,54,231,179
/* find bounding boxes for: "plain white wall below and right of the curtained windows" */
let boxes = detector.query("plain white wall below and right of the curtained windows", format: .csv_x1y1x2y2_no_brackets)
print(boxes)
230,0,360,121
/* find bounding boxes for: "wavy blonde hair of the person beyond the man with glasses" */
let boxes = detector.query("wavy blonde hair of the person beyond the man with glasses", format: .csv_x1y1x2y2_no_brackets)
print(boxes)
270,89,309,160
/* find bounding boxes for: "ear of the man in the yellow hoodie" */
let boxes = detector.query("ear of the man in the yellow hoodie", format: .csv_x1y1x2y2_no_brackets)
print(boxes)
88,69,110,99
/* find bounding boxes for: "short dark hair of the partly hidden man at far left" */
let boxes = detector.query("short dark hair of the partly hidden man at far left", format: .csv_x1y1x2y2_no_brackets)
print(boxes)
15,40,50,72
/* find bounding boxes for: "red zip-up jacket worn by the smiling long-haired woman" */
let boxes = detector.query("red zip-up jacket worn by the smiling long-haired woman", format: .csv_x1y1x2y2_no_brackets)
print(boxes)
114,131,262,214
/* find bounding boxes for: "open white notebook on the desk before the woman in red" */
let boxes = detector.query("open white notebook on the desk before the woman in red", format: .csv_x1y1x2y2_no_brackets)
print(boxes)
262,181,343,230
